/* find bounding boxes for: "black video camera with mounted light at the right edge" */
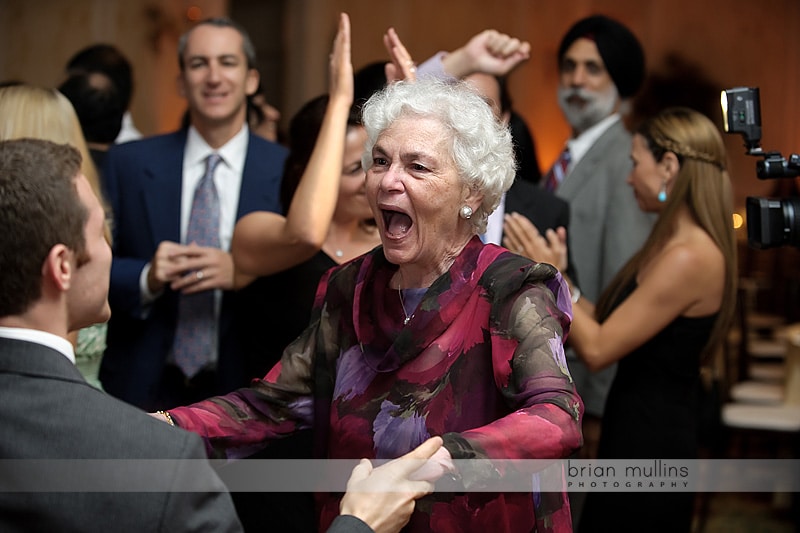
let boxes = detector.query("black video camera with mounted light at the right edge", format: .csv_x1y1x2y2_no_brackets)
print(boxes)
720,87,800,249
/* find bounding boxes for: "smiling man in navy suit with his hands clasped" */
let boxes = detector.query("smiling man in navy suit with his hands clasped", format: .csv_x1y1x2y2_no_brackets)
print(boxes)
100,15,286,411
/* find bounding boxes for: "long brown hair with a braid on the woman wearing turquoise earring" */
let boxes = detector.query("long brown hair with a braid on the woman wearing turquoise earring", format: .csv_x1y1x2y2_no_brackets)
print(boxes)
596,107,738,357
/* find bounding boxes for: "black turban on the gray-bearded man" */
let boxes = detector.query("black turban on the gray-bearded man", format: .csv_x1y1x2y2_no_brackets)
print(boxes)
558,15,644,98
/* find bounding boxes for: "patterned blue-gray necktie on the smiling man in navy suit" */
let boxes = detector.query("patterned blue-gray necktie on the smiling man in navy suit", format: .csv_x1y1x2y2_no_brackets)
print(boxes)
173,154,222,378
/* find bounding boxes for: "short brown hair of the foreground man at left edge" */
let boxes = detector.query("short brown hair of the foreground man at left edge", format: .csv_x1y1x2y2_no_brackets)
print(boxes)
0,139,89,317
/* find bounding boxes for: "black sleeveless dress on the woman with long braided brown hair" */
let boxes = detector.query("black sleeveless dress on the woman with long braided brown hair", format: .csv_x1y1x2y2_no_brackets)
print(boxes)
579,284,717,533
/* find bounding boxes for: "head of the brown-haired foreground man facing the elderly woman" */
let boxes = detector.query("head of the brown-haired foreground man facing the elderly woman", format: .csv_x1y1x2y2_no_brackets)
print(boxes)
0,139,111,333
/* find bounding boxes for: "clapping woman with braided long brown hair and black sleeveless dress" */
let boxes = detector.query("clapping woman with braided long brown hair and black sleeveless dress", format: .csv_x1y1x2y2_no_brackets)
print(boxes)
504,108,737,533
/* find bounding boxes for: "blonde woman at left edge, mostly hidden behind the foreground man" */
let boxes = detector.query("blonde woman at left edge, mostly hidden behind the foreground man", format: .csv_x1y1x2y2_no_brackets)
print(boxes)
0,83,111,387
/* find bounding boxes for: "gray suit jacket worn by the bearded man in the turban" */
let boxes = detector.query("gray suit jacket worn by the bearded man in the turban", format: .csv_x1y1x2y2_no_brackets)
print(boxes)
556,121,655,416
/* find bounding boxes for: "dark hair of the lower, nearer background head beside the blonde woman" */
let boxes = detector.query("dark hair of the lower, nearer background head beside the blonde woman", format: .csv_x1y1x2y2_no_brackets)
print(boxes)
58,72,125,144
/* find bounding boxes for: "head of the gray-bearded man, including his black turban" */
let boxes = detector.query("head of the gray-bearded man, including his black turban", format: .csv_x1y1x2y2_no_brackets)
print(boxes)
558,15,644,134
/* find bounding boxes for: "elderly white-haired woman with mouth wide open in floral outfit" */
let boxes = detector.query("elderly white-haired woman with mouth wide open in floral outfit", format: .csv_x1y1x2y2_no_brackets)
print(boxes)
170,80,583,532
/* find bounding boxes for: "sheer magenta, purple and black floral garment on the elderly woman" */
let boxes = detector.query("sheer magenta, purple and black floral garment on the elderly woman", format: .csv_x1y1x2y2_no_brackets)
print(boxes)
171,237,583,532
